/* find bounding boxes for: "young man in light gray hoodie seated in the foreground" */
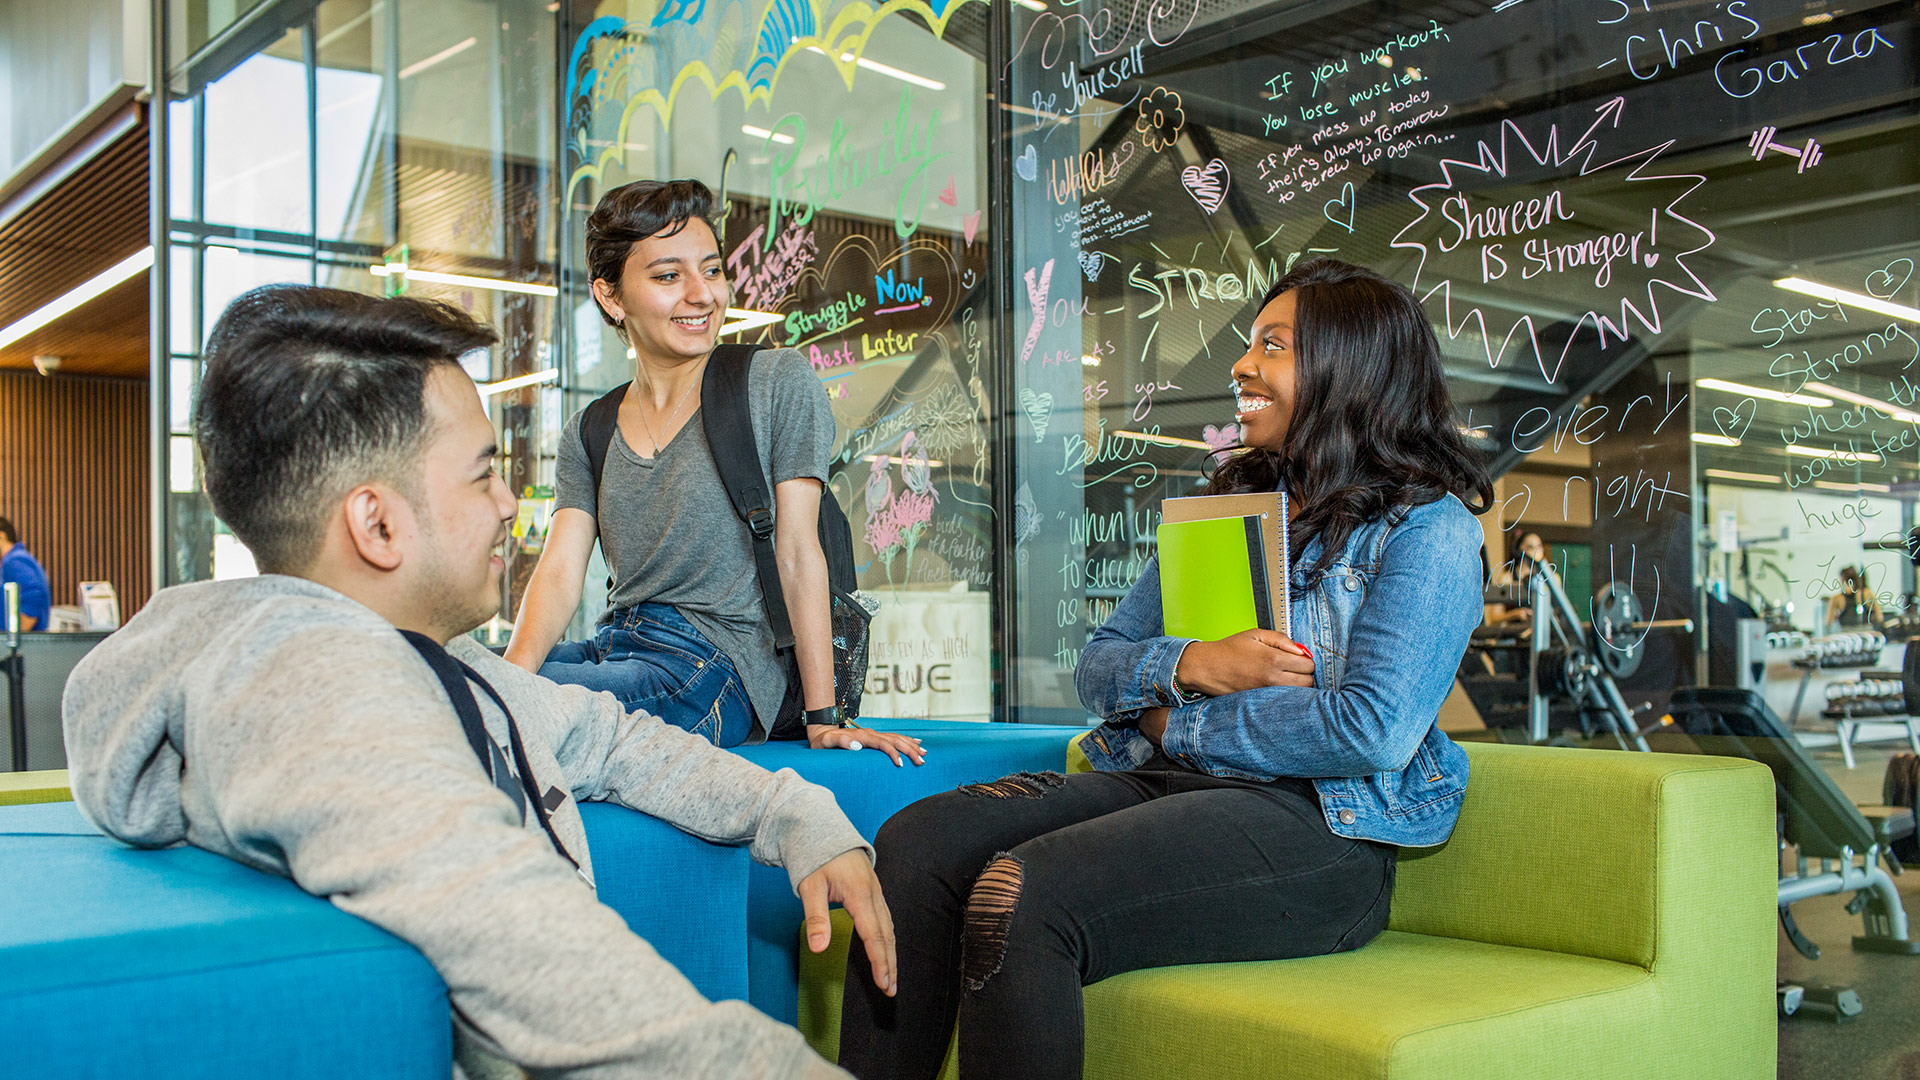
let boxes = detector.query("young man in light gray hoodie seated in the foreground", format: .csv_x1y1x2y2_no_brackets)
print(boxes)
65,286,895,1078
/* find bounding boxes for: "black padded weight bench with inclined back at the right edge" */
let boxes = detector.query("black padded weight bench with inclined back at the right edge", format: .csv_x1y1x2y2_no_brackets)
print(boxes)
1649,686,1920,959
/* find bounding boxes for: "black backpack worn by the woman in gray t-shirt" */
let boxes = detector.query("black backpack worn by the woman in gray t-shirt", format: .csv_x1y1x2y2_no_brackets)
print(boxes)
580,344,874,738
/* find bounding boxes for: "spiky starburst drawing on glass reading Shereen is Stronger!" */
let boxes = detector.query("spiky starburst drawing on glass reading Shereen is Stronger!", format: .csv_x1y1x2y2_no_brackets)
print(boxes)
1392,98,1716,382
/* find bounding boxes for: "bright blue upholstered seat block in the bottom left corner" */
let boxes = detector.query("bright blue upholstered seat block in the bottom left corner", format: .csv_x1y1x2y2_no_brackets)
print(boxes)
0,803,451,1080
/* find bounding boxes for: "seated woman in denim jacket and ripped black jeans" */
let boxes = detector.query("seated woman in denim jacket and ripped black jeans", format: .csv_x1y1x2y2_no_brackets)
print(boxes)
841,259,1492,1080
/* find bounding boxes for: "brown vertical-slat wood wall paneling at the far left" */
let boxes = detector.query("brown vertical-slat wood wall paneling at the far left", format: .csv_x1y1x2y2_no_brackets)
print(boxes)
0,371,154,617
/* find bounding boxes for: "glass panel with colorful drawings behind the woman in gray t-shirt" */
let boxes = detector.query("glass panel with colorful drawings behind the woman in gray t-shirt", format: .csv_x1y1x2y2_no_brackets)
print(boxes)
563,0,995,719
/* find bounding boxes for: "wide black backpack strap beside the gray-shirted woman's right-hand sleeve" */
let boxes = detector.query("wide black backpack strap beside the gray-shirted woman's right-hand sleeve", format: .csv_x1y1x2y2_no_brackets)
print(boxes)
701,344,793,650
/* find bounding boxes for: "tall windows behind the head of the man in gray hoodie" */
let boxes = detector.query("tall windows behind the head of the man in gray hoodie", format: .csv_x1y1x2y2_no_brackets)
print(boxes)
167,0,559,626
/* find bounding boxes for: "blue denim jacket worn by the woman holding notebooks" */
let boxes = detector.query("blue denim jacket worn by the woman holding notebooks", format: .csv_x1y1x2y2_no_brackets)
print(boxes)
1073,496,1482,847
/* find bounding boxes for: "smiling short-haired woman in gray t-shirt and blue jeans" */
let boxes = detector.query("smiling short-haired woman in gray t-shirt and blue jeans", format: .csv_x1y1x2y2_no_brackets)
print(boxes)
507,181,924,765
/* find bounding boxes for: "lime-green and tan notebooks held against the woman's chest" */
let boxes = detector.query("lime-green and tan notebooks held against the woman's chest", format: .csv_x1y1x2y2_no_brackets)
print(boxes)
1158,492,1294,642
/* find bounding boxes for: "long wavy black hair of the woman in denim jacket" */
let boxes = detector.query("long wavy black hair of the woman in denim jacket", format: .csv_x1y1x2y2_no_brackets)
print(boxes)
1206,259,1494,569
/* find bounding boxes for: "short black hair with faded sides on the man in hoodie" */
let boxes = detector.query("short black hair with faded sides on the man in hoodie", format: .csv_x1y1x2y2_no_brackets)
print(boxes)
194,284,495,573
